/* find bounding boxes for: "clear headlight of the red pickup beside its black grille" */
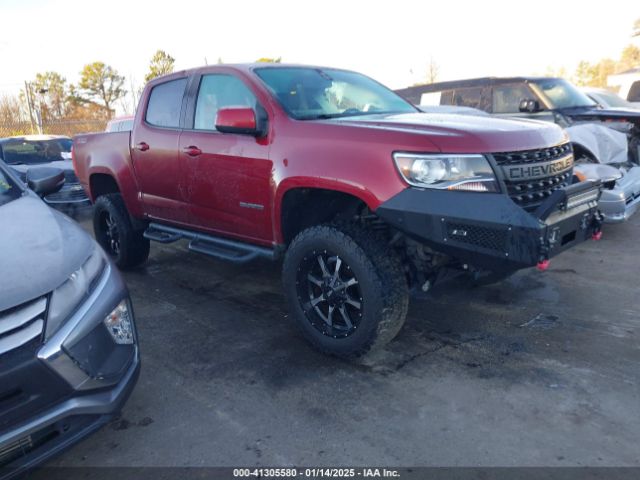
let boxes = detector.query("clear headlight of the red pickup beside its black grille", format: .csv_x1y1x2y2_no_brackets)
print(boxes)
393,153,499,192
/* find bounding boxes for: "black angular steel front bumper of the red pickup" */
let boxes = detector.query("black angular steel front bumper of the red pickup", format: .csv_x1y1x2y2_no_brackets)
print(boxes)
376,182,601,272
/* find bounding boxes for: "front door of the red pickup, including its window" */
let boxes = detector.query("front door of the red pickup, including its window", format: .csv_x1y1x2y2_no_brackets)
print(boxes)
179,72,273,244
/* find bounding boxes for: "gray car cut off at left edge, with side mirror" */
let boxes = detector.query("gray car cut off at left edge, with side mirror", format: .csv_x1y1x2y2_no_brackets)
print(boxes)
0,161,140,478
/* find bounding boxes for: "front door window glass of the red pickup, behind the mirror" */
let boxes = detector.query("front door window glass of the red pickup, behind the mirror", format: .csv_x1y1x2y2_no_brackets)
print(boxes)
194,74,256,130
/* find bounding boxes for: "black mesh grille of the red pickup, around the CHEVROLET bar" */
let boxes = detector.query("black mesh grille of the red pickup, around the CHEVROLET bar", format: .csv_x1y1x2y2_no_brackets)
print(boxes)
492,143,573,212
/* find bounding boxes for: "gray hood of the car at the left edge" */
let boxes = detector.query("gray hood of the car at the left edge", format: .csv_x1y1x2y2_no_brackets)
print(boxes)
0,192,95,311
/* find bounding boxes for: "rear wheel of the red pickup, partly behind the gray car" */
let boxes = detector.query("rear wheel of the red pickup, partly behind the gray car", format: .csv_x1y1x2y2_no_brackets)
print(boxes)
93,193,150,270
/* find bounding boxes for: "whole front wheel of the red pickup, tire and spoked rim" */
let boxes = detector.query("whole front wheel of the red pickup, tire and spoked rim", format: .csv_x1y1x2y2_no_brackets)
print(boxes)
283,224,409,358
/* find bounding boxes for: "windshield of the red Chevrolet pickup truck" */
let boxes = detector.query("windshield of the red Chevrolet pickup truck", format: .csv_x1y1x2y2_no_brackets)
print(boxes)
255,67,417,120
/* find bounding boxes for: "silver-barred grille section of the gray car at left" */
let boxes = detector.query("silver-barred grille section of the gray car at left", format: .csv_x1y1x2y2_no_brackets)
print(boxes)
0,297,47,355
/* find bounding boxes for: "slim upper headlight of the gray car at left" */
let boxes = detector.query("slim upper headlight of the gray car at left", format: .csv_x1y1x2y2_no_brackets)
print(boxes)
45,248,105,340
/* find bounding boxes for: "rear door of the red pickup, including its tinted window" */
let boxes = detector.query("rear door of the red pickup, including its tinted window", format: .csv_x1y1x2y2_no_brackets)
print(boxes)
131,76,188,222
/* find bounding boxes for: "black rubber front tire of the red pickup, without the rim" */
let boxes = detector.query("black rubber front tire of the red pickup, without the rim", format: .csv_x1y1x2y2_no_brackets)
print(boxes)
283,223,409,359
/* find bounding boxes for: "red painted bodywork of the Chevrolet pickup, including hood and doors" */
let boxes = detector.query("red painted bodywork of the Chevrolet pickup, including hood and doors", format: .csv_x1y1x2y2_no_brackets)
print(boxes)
75,65,566,245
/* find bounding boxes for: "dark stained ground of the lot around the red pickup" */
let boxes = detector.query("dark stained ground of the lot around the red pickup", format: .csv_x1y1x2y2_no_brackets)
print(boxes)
42,216,640,466
